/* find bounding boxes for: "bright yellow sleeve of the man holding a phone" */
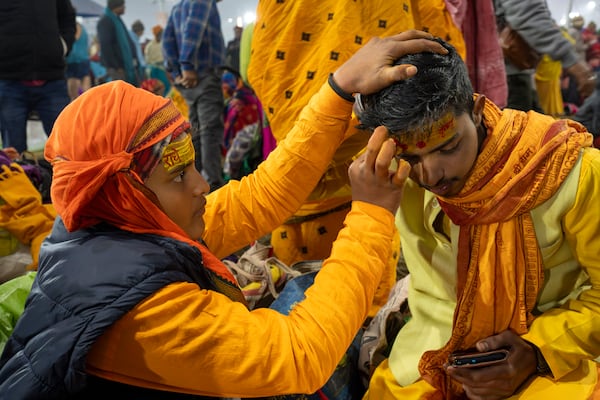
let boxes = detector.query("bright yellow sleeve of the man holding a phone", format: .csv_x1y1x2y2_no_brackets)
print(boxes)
523,149,600,379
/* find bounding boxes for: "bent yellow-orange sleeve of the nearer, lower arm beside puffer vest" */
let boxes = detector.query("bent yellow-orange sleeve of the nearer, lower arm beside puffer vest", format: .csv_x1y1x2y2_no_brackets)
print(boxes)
83,202,395,397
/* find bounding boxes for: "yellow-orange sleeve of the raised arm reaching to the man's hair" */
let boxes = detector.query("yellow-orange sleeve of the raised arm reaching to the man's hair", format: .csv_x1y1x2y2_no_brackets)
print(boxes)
203,84,352,258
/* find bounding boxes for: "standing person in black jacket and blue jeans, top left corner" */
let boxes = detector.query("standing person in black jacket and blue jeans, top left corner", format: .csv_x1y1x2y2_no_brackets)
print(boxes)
0,0,76,153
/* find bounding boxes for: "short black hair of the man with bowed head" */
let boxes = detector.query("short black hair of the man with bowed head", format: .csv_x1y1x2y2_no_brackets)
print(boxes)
358,39,474,139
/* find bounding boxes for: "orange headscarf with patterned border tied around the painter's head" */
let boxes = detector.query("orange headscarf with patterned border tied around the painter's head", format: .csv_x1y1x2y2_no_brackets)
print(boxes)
44,81,243,301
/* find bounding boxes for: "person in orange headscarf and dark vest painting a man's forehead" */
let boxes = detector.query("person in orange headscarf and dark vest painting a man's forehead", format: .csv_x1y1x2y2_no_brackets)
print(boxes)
0,32,445,399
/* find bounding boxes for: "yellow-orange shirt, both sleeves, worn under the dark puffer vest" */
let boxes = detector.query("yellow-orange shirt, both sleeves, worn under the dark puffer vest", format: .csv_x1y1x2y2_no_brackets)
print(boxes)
88,85,396,397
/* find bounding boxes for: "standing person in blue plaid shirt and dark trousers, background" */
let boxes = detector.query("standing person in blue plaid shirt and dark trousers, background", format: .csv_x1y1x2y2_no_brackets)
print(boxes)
162,0,225,191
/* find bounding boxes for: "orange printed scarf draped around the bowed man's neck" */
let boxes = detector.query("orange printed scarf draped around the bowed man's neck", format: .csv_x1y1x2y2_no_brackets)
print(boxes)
419,96,592,399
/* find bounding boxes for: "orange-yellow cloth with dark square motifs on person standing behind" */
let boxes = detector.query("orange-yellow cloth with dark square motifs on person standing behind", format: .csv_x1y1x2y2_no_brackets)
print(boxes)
242,0,465,310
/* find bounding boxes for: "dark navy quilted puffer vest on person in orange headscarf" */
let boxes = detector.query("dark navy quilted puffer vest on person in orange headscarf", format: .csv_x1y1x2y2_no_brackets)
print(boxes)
0,219,220,400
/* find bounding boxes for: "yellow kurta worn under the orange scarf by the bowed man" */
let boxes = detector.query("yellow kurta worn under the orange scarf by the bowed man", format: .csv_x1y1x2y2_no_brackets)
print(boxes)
365,148,600,400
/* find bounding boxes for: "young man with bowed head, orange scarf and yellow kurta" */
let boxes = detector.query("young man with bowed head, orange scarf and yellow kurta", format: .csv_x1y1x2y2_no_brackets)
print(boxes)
357,36,600,400
